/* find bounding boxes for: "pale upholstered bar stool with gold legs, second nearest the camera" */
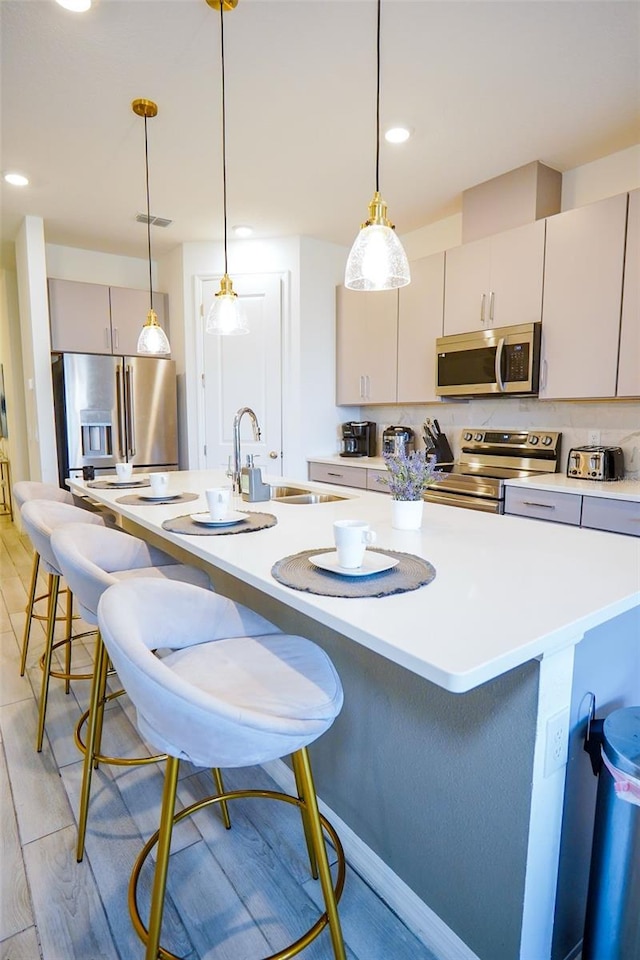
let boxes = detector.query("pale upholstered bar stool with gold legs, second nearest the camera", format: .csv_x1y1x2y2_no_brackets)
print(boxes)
51,523,220,862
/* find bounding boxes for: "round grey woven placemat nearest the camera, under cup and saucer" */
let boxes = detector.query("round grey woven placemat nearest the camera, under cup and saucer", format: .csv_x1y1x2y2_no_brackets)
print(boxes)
271,547,436,597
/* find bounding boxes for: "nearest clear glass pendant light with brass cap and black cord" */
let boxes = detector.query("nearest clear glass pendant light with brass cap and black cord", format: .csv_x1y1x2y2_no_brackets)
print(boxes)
344,0,411,290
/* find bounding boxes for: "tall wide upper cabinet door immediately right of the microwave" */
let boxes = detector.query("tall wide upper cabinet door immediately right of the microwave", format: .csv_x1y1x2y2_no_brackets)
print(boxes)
540,193,637,400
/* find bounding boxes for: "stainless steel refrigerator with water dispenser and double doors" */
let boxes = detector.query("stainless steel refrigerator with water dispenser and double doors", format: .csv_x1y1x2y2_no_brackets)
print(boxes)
51,353,178,485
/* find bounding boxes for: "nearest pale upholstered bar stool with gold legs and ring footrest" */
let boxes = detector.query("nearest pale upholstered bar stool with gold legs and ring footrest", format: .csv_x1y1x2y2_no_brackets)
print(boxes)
98,580,345,960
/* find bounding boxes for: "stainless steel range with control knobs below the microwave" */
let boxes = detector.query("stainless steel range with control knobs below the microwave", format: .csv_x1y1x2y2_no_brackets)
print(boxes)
425,427,562,513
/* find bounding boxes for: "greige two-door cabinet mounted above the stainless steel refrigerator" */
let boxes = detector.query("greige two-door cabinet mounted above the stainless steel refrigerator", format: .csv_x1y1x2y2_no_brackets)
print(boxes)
48,279,168,355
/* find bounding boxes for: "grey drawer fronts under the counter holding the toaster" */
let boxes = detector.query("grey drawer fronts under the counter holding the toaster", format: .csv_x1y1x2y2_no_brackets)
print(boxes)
505,487,640,537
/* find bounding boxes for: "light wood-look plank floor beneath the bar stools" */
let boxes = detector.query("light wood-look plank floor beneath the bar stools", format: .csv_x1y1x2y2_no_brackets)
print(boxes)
0,517,436,960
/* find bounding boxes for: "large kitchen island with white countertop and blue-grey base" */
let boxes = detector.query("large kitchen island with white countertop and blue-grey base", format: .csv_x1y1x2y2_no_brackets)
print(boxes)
69,472,640,960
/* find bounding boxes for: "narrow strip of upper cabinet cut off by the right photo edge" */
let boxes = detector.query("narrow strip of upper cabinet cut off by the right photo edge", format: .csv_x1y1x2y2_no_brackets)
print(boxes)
617,190,640,397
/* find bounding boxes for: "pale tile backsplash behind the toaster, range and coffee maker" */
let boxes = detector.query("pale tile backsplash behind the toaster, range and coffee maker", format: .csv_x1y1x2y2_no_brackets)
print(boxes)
358,397,640,479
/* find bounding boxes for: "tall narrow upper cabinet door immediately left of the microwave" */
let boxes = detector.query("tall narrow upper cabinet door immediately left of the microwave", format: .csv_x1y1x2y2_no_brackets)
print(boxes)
397,253,444,403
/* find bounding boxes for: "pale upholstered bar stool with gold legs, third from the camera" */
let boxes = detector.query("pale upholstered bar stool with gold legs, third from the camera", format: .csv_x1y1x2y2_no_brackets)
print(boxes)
20,500,105,753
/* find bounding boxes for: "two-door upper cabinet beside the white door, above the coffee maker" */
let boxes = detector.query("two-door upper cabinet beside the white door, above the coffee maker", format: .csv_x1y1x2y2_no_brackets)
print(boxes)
336,286,398,405
